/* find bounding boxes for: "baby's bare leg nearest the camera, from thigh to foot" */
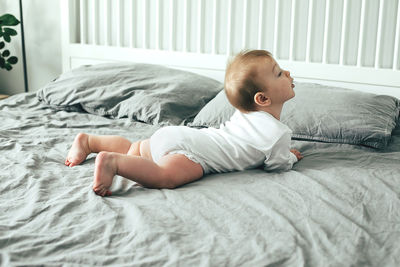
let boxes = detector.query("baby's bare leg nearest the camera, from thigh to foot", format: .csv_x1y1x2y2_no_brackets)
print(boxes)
93,152,203,196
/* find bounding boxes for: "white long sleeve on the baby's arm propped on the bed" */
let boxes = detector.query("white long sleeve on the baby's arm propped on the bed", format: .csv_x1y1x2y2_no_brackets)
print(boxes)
264,132,297,171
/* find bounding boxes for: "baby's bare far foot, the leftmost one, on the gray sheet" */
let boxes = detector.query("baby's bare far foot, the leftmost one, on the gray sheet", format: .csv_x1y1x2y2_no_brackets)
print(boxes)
65,133,91,167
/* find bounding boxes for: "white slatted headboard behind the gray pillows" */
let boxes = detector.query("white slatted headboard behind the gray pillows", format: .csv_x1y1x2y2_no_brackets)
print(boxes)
61,0,400,98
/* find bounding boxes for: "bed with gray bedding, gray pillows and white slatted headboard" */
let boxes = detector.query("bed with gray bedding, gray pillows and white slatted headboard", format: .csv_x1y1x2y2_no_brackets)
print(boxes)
0,0,400,266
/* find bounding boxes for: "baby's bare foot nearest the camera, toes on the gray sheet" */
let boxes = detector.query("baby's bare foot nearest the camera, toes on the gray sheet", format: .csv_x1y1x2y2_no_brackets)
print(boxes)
93,152,117,197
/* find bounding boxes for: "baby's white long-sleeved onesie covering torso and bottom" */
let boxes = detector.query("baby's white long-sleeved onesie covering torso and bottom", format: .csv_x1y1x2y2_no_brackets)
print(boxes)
150,110,297,174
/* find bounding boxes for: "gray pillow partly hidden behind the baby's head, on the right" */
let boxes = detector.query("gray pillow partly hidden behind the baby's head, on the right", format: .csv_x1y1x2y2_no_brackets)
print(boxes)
189,83,400,148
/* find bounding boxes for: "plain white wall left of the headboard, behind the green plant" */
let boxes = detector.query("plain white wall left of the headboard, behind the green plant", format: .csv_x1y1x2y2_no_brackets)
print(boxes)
0,0,61,95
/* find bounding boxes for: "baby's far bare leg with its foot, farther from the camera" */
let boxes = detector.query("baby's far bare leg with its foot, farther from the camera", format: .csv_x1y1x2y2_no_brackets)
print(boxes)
65,133,139,167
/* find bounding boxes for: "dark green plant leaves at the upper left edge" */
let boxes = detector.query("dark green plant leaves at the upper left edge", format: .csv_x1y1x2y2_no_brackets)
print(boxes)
0,14,19,70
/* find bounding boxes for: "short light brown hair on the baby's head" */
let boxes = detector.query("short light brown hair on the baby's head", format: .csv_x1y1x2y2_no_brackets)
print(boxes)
224,50,272,112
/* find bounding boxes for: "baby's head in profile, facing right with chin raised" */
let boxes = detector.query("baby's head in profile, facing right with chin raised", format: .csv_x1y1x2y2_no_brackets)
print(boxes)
224,50,294,112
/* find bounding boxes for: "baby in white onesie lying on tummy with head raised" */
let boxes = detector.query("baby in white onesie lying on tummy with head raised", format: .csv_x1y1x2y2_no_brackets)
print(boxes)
65,50,303,196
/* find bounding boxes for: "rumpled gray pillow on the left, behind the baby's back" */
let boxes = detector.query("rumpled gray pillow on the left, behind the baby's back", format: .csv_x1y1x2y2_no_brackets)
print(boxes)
37,63,223,125
